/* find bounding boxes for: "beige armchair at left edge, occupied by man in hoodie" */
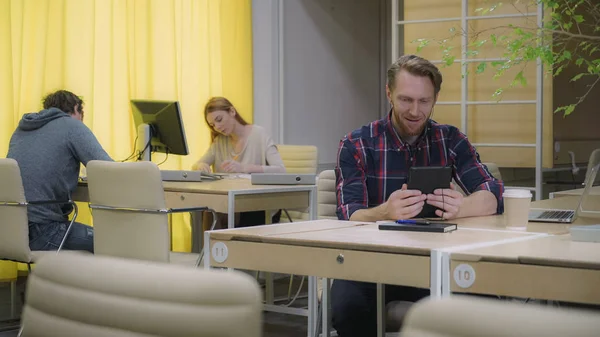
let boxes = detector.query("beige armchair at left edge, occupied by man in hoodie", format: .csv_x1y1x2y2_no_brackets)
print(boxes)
0,158,77,317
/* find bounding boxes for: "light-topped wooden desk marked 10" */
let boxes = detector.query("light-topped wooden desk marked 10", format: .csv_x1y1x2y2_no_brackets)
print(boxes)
445,235,600,304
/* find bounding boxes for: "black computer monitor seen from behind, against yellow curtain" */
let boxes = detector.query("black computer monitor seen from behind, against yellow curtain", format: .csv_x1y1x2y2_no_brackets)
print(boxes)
131,99,189,161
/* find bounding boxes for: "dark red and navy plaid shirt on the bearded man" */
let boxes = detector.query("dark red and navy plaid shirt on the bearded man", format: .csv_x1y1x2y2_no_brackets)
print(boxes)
335,114,504,220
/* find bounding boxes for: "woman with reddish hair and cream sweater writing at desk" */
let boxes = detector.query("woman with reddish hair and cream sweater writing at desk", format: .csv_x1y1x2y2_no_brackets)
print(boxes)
192,97,285,230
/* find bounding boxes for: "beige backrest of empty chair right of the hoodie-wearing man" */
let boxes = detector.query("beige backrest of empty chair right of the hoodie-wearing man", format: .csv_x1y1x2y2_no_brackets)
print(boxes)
87,161,171,262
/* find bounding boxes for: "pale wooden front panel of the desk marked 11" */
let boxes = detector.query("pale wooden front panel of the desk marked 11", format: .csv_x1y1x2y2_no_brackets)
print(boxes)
210,240,431,288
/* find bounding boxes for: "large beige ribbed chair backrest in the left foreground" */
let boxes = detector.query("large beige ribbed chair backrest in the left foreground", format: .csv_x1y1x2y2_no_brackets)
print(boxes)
22,252,262,337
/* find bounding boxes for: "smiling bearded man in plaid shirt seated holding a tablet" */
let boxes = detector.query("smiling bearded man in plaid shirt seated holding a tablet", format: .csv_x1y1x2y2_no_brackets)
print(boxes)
331,55,504,337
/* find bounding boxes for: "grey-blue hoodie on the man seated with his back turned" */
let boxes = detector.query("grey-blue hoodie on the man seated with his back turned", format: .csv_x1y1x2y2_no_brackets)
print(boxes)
7,108,112,224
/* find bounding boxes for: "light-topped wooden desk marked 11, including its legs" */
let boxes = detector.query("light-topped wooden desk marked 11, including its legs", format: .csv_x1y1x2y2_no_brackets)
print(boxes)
204,220,540,336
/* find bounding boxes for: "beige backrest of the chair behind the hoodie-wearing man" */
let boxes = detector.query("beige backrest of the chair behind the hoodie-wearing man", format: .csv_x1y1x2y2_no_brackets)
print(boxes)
0,158,31,262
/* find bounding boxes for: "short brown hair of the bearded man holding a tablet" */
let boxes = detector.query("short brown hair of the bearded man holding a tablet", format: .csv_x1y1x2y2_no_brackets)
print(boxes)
387,55,442,95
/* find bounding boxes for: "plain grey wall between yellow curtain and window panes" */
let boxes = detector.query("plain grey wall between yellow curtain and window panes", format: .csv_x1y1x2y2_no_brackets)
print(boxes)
252,0,389,167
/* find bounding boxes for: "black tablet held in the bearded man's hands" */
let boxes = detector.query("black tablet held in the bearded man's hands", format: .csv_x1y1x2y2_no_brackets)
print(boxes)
407,166,452,218
